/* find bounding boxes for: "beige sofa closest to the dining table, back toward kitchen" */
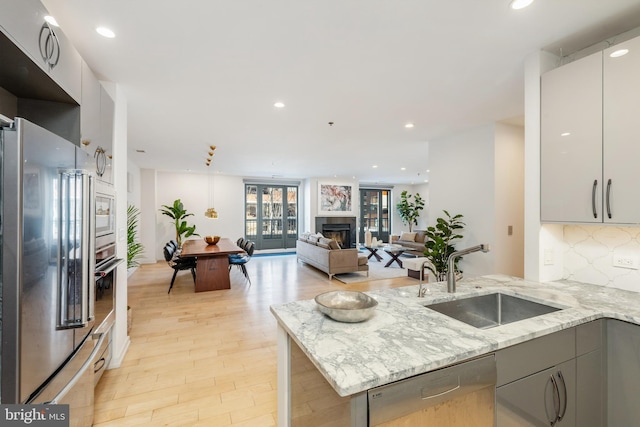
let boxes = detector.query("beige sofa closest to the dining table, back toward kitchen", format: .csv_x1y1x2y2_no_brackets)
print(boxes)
296,233,369,279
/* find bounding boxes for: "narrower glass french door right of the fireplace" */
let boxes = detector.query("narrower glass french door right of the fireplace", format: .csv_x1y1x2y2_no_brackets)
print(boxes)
359,189,391,246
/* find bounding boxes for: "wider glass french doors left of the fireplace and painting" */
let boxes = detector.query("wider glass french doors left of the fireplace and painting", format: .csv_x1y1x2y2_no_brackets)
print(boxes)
245,184,298,249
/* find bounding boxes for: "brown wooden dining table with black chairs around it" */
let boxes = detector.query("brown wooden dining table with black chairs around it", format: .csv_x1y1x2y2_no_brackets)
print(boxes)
180,238,244,292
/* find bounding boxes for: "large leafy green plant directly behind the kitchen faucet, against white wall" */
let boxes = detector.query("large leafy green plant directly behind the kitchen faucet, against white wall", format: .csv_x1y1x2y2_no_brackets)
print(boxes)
424,211,465,282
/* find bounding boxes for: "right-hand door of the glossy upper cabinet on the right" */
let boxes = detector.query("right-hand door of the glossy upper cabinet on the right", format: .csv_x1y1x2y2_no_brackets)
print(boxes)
603,38,640,224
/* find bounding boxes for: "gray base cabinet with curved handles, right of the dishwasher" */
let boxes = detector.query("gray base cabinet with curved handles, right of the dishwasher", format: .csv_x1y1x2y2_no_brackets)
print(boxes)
496,320,604,427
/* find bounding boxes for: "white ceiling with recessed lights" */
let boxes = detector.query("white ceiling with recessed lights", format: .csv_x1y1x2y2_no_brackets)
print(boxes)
43,0,640,184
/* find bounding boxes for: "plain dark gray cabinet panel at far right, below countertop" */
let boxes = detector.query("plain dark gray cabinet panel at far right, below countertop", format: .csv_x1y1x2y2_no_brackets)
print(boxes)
607,320,640,427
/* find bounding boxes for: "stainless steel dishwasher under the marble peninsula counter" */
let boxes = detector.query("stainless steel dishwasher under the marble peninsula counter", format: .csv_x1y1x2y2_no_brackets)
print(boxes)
367,355,496,427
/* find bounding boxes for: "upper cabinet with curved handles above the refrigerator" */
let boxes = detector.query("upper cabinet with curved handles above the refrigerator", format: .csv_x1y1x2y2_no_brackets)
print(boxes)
0,0,82,103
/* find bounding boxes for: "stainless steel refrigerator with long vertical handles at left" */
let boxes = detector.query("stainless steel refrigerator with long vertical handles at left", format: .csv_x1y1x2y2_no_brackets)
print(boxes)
0,118,104,427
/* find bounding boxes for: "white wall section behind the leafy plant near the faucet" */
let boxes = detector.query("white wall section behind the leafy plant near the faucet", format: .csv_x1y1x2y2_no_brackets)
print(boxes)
428,125,497,276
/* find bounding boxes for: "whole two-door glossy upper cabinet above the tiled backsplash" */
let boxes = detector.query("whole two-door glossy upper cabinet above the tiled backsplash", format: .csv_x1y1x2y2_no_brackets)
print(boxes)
540,32,640,224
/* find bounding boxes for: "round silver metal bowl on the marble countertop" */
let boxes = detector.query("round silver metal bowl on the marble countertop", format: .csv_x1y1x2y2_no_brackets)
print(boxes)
315,291,378,323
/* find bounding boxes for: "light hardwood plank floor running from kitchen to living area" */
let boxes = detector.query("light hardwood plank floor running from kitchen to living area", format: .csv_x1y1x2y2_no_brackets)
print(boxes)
94,255,416,427
